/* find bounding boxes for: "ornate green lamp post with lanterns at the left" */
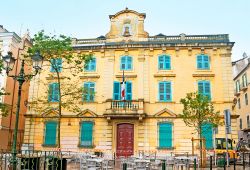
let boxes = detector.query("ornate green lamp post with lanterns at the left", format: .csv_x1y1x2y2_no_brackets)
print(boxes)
2,52,43,170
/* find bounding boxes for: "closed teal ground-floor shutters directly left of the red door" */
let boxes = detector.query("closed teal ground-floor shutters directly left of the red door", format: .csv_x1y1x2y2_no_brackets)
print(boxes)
80,122,93,147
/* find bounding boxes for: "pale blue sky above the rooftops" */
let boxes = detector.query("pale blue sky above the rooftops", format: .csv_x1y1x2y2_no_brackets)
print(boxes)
0,0,250,60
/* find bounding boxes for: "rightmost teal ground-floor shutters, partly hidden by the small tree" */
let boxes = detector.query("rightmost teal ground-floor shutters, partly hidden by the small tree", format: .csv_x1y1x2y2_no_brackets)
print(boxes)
201,123,213,149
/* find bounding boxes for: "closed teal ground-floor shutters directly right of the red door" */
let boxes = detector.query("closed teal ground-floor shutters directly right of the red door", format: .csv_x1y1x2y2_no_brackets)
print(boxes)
158,122,173,148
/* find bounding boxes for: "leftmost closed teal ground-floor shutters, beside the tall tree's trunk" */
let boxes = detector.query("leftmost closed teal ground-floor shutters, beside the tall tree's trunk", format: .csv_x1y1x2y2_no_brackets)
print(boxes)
44,122,57,145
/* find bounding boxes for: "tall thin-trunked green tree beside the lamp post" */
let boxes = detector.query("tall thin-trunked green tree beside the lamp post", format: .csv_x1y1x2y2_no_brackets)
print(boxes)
26,30,92,148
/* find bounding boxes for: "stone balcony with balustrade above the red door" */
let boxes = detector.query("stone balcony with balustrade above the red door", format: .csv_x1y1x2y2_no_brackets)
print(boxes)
104,99,145,119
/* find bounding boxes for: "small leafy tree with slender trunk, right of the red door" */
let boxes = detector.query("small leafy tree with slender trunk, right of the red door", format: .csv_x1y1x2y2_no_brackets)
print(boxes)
180,92,220,167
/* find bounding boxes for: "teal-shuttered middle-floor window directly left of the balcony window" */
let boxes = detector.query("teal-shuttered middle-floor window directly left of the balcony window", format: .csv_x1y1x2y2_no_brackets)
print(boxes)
82,82,95,102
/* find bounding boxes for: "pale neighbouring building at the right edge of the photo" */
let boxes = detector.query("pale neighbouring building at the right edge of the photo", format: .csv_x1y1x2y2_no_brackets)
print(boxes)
232,53,250,141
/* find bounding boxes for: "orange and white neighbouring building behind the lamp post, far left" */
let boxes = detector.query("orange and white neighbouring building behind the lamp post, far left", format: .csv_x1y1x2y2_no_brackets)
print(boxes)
0,25,31,150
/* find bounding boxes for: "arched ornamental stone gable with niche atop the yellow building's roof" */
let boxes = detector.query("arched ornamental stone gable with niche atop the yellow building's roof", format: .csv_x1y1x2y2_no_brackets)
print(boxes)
106,8,148,42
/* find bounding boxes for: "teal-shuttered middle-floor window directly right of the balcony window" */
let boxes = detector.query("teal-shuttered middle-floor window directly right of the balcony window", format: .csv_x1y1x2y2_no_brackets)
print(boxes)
158,81,172,102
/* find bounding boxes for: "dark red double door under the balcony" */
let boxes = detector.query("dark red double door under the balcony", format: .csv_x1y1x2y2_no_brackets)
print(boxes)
116,123,134,157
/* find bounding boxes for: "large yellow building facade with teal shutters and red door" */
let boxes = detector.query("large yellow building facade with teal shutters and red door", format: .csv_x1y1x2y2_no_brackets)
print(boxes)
24,9,237,156
